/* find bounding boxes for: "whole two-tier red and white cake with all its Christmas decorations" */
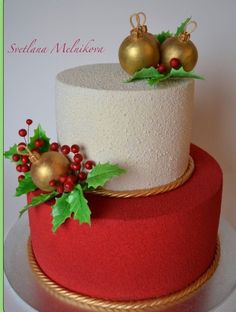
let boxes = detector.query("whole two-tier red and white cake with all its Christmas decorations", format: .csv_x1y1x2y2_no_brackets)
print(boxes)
5,12,222,312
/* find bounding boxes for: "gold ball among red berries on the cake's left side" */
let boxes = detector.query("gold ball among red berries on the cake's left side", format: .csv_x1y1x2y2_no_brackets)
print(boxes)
30,151,70,192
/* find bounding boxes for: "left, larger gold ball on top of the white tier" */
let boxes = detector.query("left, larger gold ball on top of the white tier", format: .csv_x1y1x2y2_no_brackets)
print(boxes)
119,33,160,75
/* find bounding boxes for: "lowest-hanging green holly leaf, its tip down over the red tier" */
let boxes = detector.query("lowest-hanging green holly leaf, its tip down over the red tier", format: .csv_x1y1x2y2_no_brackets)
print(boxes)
52,193,71,232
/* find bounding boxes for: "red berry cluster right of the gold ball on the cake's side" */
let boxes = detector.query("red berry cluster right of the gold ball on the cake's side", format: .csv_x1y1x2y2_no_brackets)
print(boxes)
49,142,95,193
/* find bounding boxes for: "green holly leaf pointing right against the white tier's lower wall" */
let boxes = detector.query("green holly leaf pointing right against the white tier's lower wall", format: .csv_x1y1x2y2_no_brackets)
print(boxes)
86,163,126,188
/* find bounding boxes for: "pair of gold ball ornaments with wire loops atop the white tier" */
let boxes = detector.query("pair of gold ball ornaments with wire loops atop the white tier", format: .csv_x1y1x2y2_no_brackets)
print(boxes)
119,12,198,75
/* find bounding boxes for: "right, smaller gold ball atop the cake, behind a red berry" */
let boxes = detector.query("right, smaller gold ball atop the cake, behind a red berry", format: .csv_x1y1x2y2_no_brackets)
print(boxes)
161,37,198,71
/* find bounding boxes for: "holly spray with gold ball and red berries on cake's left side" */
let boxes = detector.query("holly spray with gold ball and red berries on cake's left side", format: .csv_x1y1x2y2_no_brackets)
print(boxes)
4,119,125,232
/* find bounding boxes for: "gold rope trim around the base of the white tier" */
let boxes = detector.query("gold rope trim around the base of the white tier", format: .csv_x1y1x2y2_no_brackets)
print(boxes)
91,156,194,198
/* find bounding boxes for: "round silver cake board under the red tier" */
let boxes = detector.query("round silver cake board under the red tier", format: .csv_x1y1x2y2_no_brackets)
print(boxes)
5,216,236,312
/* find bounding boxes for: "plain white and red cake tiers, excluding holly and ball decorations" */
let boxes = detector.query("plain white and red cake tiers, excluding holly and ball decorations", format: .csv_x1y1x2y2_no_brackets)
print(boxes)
28,64,222,311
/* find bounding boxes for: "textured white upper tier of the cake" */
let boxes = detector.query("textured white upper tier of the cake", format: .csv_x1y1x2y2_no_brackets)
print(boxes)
56,64,194,190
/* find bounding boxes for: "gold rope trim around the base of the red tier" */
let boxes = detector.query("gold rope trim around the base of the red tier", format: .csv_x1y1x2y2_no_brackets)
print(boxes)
28,238,220,312
